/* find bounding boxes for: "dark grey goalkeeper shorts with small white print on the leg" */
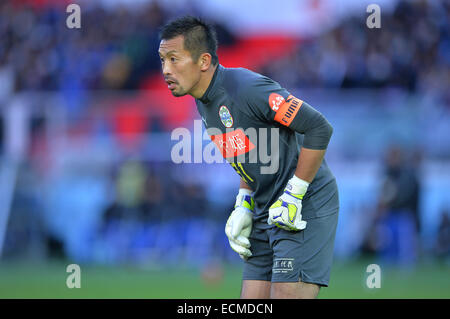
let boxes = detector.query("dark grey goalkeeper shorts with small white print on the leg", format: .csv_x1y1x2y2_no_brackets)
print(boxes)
242,209,338,287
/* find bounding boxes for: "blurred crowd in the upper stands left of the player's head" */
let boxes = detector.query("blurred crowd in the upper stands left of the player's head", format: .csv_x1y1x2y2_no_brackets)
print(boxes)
0,1,237,95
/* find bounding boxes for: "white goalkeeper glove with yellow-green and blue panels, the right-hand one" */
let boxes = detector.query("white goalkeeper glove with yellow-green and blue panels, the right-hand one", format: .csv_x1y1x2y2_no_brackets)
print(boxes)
267,175,309,231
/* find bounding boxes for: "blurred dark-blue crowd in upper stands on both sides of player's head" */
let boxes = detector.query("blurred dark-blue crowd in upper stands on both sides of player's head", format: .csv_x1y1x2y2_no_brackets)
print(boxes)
0,1,450,101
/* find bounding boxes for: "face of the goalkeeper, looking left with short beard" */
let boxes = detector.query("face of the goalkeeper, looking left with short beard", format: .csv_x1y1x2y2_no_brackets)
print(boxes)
159,35,201,96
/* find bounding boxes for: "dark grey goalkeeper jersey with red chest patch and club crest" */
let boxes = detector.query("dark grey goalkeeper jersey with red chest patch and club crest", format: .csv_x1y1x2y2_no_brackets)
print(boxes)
195,65,339,227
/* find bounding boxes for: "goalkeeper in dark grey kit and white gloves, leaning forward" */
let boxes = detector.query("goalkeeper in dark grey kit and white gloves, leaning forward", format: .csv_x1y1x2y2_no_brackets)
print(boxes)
159,17,339,298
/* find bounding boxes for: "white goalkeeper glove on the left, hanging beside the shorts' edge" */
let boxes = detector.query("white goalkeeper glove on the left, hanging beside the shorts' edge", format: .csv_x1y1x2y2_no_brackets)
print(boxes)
225,188,255,260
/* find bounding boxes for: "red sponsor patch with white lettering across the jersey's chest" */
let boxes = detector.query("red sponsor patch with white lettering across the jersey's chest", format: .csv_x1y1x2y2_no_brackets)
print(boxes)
211,129,255,158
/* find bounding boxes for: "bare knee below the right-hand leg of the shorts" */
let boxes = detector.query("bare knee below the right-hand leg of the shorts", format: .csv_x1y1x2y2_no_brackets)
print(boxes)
270,281,320,299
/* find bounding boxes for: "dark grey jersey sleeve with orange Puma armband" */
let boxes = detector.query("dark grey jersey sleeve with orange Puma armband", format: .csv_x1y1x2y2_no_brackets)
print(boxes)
240,75,333,150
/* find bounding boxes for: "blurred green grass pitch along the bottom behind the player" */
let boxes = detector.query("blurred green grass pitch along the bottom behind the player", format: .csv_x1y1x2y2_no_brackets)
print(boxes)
0,260,450,299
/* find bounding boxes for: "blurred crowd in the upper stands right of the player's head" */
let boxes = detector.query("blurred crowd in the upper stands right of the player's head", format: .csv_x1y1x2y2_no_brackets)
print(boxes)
263,1,450,105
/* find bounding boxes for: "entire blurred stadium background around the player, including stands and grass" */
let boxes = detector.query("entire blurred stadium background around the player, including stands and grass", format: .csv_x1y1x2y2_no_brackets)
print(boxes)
0,0,450,298
